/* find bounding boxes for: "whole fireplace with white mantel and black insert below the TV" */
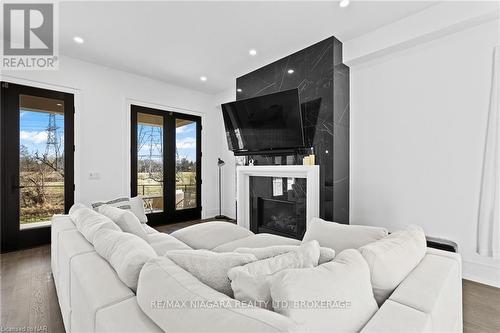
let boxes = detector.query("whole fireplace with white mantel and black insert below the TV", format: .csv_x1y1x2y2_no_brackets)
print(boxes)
236,165,320,235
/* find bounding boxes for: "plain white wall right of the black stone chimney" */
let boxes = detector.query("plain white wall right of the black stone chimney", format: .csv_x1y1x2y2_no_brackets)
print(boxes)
350,18,500,286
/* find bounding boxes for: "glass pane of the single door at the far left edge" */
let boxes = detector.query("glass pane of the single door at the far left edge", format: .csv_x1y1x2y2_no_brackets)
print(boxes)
19,95,64,229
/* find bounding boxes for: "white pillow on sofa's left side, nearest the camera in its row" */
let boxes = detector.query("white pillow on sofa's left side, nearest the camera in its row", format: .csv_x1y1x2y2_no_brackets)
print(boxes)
94,230,156,291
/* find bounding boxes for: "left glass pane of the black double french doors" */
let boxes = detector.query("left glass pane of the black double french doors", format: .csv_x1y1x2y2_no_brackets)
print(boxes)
137,113,164,213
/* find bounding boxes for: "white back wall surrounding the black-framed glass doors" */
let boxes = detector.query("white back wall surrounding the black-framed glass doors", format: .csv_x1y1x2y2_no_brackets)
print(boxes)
2,57,219,217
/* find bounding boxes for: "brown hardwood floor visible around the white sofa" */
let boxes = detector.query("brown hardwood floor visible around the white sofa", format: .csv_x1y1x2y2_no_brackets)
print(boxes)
0,220,500,333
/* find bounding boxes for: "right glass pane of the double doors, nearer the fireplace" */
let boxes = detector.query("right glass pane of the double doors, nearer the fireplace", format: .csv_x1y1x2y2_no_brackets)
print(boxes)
175,119,197,210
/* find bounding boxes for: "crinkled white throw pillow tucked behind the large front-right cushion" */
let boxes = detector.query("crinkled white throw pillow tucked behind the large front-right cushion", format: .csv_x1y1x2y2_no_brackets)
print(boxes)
227,241,319,309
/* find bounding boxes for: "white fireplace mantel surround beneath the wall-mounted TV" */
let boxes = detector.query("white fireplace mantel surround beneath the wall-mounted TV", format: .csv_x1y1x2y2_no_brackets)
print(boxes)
236,165,319,229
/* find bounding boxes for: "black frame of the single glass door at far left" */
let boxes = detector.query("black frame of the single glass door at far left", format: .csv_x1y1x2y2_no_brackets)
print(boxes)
0,82,75,252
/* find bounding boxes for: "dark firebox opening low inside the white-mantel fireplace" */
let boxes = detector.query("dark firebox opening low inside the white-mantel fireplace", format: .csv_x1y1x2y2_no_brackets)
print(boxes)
257,197,306,238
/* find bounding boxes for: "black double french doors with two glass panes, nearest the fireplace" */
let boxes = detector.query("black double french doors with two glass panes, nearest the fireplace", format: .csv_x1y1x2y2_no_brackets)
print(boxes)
131,105,201,224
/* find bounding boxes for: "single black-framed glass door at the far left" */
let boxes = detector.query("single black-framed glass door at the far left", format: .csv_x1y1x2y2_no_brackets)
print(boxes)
1,82,74,251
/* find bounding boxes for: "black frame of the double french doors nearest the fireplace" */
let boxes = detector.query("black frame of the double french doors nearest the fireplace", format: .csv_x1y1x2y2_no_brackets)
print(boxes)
130,104,202,225
